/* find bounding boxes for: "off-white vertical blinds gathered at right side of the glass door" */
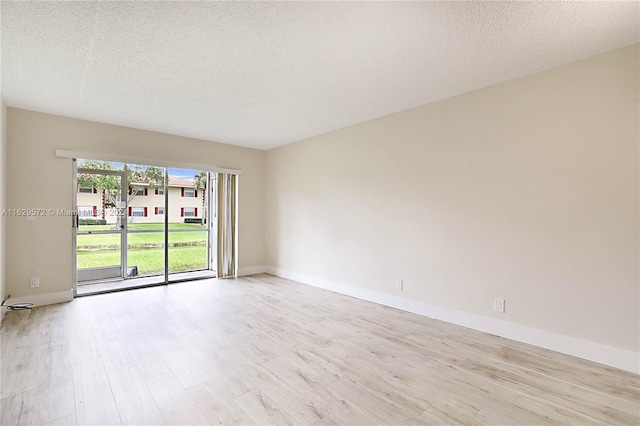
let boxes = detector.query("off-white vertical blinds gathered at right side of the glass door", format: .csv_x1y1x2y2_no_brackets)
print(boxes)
216,173,238,278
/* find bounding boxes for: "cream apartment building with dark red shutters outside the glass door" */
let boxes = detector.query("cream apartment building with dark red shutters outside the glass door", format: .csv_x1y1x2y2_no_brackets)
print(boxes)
78,176,205,224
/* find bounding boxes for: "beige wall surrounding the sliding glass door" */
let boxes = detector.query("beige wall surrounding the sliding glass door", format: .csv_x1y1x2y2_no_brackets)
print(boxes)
6,108,265,297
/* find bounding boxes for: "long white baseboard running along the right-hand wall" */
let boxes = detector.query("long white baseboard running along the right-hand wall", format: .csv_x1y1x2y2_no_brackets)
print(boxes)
266,266,640,374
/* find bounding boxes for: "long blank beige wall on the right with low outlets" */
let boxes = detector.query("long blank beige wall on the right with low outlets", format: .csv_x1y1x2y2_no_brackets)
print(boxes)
265,45,640,352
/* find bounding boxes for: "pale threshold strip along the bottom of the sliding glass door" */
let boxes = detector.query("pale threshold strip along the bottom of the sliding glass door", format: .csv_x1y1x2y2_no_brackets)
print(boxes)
76,271,216,296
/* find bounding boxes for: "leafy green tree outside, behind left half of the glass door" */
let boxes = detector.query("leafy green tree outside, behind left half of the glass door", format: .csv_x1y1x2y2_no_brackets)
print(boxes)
77,160,164,219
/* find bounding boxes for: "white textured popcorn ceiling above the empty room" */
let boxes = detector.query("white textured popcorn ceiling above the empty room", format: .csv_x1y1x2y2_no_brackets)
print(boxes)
0,1,640,149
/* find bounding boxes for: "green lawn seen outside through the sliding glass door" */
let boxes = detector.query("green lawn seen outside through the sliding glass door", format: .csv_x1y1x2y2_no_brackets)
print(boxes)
77,223,207,276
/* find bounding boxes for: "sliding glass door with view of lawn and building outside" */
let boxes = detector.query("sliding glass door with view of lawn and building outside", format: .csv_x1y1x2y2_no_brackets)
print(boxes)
74,160,215,294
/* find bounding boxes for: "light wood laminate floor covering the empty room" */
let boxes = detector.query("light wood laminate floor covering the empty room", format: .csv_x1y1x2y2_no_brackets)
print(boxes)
0,275,640,425
